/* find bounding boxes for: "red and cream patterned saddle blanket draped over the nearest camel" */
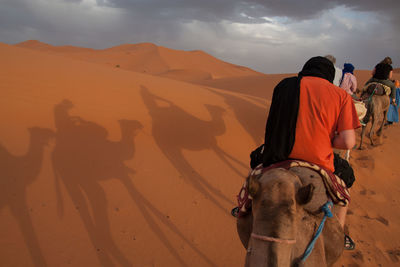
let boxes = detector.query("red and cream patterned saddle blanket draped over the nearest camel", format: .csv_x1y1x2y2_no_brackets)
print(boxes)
237,160,350,217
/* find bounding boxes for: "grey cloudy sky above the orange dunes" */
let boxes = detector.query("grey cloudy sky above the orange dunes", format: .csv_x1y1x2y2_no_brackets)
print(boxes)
0,0,400,73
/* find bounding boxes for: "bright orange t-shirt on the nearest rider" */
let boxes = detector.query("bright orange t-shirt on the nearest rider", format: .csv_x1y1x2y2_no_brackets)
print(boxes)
289,76,360,172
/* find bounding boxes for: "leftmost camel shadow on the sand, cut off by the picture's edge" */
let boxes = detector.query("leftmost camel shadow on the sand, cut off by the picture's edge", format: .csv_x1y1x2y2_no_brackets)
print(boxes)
0,127,54,267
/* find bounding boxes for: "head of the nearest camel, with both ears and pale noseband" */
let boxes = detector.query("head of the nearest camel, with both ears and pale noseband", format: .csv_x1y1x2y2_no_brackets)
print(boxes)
245,168,314,266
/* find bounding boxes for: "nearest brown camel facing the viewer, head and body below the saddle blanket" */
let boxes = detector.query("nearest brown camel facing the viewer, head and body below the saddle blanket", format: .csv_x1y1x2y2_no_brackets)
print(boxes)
237,167,344,267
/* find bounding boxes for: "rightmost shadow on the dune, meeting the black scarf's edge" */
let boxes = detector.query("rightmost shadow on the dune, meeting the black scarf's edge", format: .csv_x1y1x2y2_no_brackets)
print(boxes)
206,90,267,145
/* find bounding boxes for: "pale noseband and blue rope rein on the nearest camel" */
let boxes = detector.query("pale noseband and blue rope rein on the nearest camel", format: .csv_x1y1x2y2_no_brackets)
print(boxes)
251,200,333,262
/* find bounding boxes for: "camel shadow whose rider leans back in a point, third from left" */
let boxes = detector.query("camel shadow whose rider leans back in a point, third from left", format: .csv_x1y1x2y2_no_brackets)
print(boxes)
141,86,243,212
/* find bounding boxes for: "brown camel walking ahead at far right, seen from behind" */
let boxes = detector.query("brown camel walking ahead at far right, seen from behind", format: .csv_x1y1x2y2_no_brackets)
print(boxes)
359,84,390,149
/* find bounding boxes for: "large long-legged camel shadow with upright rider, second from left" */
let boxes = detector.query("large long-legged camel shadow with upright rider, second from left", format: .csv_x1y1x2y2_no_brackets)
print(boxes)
52,100,214,266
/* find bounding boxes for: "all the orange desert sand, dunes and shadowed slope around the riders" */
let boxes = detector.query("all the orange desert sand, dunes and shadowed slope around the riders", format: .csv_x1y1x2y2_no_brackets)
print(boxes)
0,41,400,267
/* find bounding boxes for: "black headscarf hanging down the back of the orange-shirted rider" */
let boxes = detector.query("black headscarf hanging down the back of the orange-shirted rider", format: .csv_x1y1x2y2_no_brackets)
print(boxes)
263,57,335,167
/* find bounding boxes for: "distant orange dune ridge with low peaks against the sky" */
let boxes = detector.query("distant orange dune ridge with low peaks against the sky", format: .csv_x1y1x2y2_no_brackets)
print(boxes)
16,40,261,81
